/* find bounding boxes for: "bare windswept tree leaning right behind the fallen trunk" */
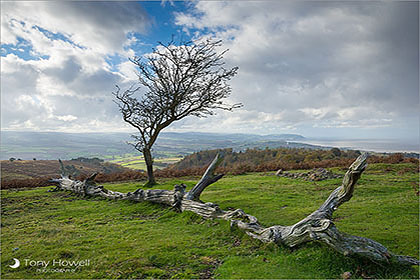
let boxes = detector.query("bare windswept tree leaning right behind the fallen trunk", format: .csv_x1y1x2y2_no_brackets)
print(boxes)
113,39,240,185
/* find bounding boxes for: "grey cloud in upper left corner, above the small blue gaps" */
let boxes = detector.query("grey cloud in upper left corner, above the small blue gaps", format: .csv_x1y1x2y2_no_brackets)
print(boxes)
2,1,151,53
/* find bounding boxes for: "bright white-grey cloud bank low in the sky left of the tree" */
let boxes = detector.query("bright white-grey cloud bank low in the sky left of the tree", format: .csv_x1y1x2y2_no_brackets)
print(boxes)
2,58,125,130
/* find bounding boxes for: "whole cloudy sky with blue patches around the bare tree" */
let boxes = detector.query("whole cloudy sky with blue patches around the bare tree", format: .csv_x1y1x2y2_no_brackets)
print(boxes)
1,1,419,142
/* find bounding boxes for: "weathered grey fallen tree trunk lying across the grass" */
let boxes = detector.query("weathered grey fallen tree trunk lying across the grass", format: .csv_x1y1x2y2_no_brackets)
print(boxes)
51,154,420,265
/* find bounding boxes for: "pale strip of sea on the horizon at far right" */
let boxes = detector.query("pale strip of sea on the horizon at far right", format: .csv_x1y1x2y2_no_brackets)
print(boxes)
293,138,420,153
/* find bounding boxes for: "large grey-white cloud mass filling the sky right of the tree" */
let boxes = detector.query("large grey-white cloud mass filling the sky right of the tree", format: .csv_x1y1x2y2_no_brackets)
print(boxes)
176,1,419,137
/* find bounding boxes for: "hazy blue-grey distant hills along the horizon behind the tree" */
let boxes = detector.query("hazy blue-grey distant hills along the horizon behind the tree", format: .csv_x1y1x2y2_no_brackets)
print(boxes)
0,131,312,160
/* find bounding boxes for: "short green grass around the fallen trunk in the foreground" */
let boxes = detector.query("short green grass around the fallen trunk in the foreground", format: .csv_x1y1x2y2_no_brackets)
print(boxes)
1,164,419,279
